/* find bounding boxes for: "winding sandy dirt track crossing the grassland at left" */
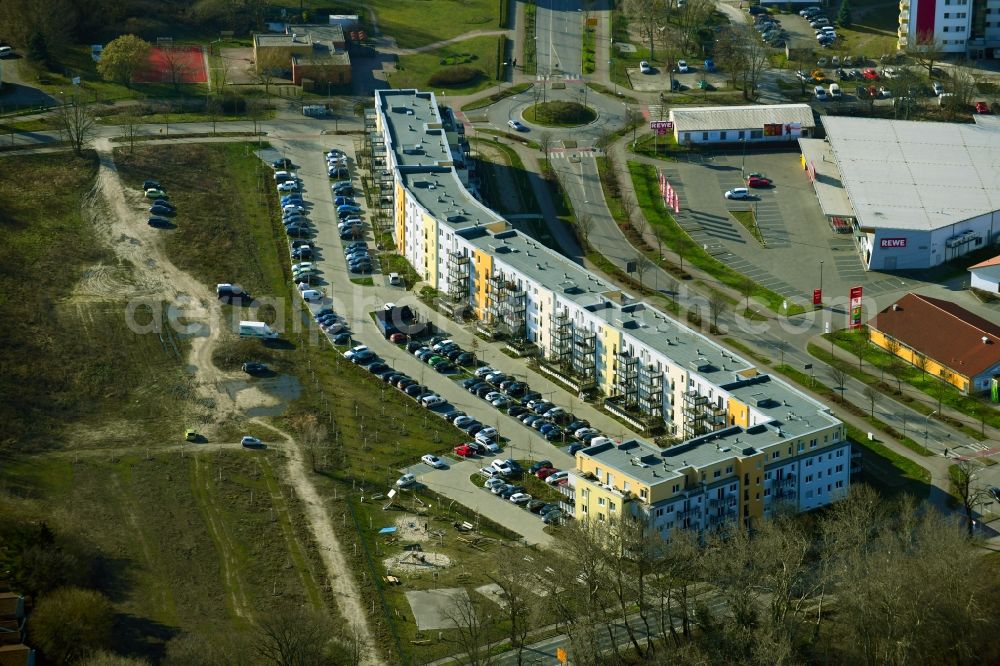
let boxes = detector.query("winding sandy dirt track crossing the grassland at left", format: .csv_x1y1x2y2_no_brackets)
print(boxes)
84,139,383,666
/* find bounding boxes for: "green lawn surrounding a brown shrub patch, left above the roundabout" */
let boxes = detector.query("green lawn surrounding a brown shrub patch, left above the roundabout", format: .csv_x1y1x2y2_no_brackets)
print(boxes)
389,35,497,95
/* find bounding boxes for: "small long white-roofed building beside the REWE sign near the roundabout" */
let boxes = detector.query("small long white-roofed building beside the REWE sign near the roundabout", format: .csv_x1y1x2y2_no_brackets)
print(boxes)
669,104,816,144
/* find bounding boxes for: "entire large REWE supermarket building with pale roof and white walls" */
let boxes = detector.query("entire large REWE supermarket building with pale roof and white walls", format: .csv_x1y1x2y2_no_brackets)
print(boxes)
799,116,1000,270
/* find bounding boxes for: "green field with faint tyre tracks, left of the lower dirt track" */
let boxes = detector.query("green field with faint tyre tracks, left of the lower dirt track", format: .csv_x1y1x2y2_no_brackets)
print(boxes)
0,444,328,658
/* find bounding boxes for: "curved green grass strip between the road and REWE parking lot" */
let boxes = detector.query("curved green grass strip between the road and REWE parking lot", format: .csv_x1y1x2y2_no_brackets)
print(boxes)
628,162,804,315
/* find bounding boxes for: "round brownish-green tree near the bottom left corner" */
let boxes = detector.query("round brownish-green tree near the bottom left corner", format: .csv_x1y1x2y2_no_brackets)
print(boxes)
28,587,114,664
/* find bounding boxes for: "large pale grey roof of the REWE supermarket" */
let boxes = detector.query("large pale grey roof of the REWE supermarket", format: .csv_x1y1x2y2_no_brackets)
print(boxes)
823,116,1000,231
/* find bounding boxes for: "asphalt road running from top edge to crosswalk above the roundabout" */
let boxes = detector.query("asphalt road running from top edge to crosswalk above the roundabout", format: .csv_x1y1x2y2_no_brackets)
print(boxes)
535,0,583,79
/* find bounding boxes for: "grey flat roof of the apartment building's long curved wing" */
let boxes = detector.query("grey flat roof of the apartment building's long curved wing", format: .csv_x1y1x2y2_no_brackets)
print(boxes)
376,90,836,451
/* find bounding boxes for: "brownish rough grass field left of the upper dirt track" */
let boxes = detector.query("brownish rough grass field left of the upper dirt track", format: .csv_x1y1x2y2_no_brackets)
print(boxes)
0,153,198,450
